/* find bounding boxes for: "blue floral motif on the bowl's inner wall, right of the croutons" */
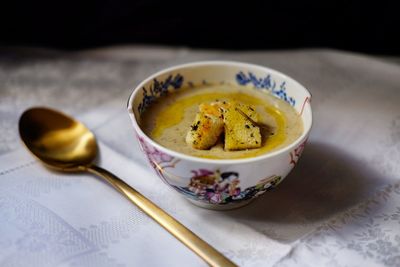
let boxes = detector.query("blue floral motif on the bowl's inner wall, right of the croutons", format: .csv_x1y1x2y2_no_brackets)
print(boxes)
236,71,296,106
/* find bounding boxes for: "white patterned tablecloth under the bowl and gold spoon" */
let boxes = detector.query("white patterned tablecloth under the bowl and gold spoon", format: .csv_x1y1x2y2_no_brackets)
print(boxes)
0,47,400,266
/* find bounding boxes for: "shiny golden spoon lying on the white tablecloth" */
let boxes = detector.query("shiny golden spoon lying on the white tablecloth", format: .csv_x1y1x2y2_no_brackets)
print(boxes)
19,107,236,266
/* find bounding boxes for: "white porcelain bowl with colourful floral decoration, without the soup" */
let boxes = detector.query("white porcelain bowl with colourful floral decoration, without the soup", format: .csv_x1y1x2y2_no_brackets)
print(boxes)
128,61,312,210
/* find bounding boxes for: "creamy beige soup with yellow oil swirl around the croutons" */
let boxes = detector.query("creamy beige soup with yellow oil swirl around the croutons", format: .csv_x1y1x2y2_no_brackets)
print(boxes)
141,84,303,159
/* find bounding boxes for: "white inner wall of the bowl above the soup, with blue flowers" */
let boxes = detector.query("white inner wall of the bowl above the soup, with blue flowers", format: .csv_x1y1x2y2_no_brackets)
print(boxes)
132,64,311,133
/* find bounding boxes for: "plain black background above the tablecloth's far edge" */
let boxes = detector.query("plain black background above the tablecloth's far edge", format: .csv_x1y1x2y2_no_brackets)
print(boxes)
0,0,400,55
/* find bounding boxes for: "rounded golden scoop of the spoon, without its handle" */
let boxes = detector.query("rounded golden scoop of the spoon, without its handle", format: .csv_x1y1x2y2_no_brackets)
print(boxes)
19,108,97,171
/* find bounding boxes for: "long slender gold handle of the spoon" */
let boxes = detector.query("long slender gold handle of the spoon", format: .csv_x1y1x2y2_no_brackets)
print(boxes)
86,165,236,266
